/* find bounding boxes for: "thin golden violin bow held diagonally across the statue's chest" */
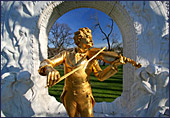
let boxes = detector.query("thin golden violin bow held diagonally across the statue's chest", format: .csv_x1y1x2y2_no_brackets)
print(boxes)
45,47,106,88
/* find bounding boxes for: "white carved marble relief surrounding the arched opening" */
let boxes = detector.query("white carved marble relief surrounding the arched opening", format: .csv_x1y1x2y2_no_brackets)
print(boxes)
1,1,169,117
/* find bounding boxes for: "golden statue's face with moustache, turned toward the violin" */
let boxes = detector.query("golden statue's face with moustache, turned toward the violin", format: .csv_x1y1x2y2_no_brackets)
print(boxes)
79,33,93,49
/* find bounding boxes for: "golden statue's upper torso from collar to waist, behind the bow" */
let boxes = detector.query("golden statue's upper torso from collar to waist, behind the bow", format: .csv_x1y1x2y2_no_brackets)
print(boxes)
64,52,92,84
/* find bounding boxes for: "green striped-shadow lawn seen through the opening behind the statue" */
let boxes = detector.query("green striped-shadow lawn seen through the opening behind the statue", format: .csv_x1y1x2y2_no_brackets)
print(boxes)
49,66,123,102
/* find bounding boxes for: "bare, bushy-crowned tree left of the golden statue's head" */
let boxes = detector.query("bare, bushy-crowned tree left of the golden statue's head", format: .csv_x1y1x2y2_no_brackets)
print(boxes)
48,22,73,52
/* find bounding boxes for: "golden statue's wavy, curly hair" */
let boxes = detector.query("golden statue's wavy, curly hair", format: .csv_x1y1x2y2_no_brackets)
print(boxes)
73,27,92,45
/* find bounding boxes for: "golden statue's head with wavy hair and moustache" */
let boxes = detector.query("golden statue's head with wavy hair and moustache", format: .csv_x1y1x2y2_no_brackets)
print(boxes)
73,27,93,49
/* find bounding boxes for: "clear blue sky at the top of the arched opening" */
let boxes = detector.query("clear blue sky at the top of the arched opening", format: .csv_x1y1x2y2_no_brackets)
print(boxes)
48,8,122,47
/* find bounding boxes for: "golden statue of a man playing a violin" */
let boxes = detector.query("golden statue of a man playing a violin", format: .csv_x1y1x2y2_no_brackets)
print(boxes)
38,27,141,117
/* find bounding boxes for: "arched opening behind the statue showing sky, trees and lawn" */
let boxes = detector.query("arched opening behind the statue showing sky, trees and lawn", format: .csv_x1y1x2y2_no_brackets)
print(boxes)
48,8,123,102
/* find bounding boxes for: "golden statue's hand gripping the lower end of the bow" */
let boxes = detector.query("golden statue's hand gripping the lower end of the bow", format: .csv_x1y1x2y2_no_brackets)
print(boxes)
46,66,60,87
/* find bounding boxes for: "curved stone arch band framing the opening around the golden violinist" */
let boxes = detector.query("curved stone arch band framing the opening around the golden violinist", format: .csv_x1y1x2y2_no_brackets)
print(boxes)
37,1,137,104
